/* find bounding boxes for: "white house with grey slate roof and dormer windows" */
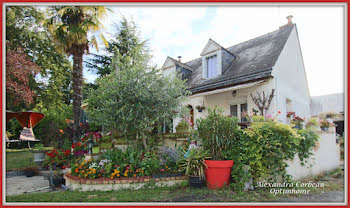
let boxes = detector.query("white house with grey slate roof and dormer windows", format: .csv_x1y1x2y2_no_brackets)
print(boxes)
162,16,311,132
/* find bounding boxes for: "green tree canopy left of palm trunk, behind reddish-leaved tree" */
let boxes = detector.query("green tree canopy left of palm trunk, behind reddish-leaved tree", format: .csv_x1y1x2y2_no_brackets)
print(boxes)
6,6,72,110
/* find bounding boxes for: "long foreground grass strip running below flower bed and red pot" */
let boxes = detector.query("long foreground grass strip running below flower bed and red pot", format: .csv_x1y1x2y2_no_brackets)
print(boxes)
6,185,274,202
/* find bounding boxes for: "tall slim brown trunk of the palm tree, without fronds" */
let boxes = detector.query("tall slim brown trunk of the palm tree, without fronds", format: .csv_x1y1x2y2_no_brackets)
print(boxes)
73,52,84,142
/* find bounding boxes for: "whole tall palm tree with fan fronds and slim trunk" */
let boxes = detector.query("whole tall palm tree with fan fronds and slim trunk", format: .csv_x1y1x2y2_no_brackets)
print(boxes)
45,6,108,141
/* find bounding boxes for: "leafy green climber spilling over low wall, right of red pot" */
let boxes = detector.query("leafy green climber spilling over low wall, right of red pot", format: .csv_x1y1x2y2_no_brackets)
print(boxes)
227,121,318,191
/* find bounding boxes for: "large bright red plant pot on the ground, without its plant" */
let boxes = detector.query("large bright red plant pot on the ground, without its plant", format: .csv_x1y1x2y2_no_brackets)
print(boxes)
205,160,233,189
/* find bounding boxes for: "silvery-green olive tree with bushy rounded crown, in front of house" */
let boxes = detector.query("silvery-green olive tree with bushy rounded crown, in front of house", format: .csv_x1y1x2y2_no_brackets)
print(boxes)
88,62,189,149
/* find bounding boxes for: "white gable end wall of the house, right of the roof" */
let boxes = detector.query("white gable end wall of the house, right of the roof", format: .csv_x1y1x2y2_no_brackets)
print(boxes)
272,27,311,122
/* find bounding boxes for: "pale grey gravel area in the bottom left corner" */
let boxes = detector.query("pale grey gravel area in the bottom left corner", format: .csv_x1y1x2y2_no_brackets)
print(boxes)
6,176,51,196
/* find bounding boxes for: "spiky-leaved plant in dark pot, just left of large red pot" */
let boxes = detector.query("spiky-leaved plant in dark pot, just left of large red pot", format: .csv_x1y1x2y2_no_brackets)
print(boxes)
179,148,209,188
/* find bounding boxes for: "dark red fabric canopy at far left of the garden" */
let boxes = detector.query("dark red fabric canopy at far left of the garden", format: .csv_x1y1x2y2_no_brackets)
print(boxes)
6,112,45,128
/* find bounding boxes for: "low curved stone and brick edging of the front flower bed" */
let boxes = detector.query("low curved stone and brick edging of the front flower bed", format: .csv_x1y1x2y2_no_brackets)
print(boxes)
63,175,188,191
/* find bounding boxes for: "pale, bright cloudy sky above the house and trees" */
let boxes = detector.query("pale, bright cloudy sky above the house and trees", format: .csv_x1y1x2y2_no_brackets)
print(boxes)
84,4,345,96
